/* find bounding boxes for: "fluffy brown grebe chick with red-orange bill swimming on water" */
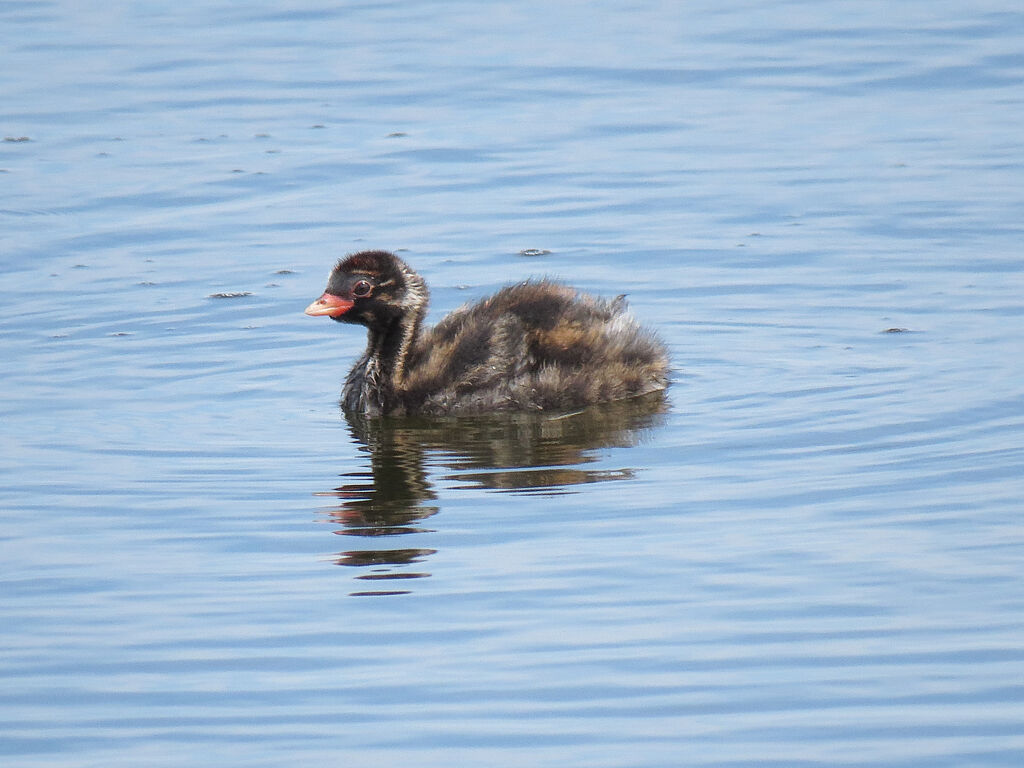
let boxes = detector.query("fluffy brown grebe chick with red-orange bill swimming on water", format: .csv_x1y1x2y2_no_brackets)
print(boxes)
306,251,669,416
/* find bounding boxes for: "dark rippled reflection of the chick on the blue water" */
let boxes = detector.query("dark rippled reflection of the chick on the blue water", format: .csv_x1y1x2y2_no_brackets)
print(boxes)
318,392,666,595
